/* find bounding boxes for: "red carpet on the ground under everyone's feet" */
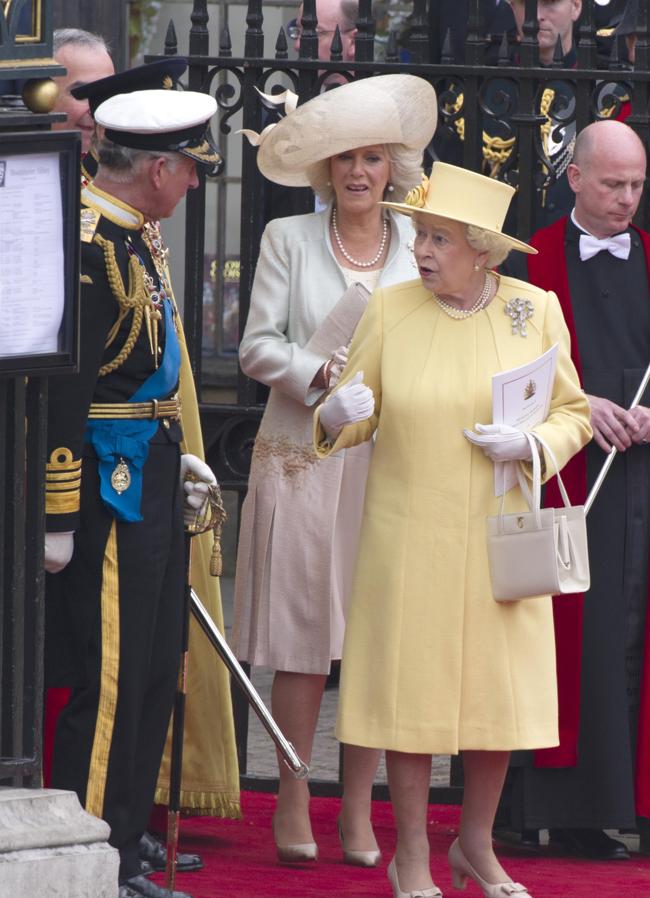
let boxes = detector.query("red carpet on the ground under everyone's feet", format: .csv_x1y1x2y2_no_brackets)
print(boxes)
149,792,650,898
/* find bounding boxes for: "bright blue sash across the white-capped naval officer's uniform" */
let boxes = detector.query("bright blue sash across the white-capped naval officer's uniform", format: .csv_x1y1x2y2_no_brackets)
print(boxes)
85,298,181,522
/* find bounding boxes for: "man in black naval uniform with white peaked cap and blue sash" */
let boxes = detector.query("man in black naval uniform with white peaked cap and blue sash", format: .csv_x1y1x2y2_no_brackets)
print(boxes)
45,90,221,898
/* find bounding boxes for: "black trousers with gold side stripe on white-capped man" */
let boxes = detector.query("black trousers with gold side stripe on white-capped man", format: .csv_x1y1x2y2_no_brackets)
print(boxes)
52,434,184,882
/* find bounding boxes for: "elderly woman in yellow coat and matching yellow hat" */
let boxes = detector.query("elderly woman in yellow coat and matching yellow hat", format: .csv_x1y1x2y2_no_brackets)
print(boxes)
315,162,591,898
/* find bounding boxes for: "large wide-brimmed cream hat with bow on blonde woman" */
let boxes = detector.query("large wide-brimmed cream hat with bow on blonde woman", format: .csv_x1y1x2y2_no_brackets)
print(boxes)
241,75,438,187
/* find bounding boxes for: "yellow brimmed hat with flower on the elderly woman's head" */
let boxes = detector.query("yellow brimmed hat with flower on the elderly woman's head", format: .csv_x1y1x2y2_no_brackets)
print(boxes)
379,162,537,253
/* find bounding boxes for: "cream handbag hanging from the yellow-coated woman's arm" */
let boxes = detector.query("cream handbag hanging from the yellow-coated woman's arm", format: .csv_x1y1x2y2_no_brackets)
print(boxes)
487,433,589,602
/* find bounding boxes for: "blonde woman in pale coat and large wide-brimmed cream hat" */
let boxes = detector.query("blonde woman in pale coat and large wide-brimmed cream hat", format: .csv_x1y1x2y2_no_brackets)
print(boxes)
233,75,436,866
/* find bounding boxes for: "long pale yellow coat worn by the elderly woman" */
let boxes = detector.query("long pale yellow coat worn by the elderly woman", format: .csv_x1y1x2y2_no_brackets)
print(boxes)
316,277,591,754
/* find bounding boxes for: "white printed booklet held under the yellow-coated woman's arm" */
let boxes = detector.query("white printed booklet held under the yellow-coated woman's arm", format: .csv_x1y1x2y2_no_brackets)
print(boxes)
466,343,557,496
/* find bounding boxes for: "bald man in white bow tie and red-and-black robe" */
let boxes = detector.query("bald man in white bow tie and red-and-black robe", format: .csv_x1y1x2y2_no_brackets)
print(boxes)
498,121,650,860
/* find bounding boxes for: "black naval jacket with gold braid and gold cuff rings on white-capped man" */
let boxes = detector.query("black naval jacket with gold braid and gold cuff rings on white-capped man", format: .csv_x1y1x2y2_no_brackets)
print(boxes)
46,185,182,532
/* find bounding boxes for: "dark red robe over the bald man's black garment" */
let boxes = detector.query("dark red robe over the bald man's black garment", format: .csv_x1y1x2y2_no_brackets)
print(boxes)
527,217,650,817
